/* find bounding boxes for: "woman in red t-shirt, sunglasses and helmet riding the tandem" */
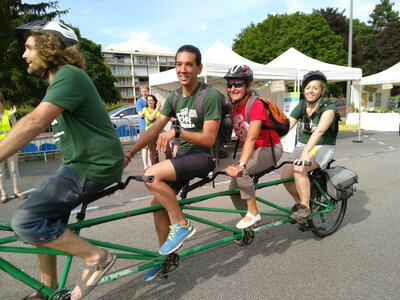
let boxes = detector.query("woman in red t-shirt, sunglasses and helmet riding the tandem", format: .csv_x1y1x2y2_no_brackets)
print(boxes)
224,65,283,229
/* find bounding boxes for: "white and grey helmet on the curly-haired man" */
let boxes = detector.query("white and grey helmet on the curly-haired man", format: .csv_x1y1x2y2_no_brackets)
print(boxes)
14,20,79,48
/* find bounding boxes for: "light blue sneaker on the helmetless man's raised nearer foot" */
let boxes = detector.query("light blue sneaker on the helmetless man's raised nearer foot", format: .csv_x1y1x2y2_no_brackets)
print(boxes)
158,221,196,255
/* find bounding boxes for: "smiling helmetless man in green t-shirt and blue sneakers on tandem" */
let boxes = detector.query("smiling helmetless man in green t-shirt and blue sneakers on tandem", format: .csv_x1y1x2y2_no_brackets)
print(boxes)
125,45,221,281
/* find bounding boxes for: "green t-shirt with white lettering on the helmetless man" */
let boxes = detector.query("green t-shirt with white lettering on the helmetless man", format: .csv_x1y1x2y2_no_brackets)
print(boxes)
161,82,222,155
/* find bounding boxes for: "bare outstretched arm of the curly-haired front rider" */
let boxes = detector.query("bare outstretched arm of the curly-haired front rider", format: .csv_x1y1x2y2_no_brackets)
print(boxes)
0,102,64,161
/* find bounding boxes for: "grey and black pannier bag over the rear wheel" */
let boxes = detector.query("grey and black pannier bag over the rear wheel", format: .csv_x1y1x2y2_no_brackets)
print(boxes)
322,167,358,200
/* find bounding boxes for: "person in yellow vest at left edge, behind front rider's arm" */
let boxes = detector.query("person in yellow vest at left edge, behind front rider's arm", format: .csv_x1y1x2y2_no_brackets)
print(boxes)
0,93,27,203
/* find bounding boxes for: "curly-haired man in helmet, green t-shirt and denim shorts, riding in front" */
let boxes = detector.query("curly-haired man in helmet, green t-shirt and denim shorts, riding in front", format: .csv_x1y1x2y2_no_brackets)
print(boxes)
0,21,123,299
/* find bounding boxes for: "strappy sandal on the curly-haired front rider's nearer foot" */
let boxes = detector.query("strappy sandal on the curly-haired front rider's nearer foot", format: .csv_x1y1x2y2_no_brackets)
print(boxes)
71,249,117,300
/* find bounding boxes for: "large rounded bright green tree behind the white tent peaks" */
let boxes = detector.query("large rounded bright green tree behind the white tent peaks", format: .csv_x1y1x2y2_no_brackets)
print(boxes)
233,12,347,65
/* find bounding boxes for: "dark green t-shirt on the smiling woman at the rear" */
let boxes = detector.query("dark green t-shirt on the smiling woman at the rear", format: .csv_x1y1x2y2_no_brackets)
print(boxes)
290,99,337,145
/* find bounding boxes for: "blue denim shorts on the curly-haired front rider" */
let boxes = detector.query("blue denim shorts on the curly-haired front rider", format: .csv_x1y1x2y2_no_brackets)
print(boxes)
11,165,107,244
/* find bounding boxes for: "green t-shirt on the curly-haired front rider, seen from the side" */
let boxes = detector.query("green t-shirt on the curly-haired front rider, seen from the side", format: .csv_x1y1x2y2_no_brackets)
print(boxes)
42,65,124,184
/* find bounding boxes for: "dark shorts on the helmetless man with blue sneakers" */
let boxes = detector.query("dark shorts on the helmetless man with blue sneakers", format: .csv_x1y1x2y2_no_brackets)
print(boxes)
167,150,215,193
